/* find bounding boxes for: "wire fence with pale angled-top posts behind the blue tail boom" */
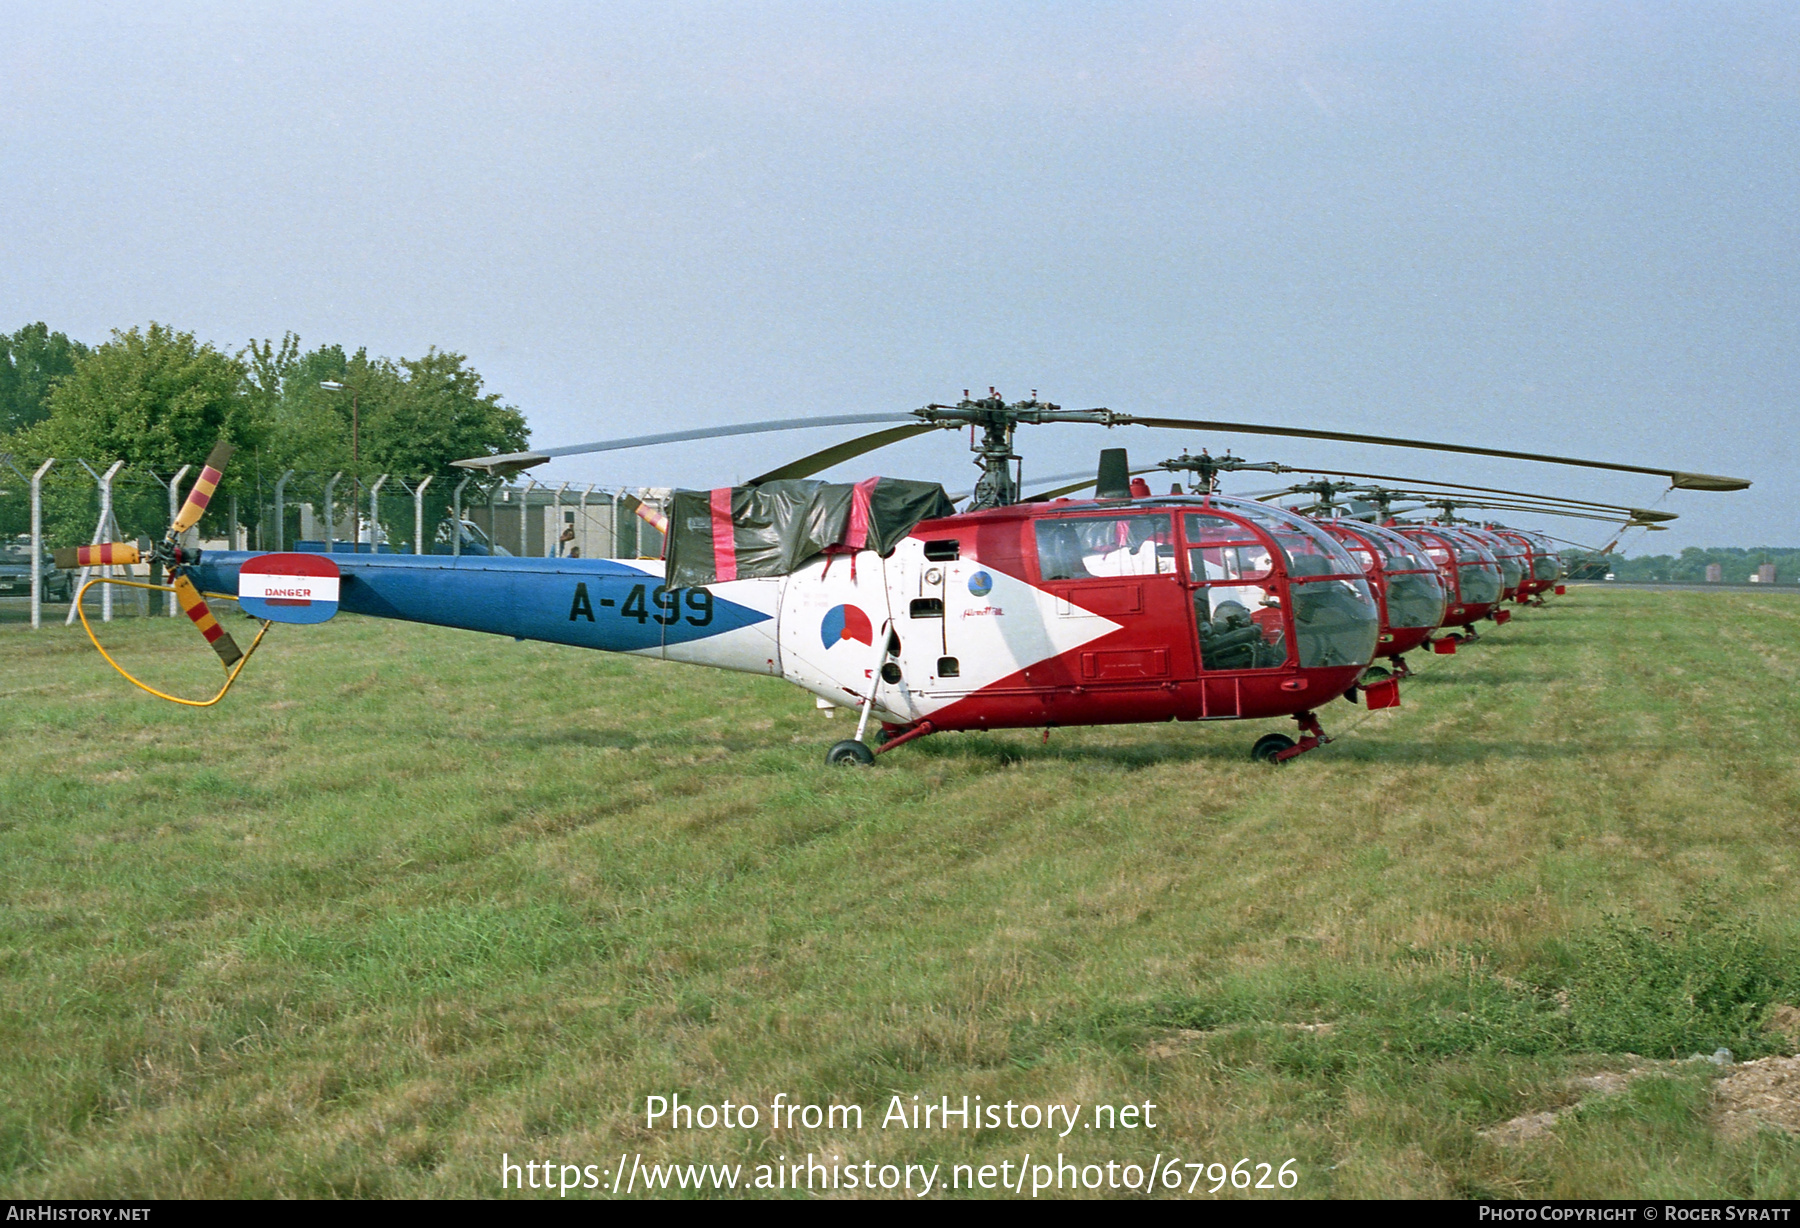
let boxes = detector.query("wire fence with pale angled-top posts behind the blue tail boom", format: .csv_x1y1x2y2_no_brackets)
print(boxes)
0,454,670,625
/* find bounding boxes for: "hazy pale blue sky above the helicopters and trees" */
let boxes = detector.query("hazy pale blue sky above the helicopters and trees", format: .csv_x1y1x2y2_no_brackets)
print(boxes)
0,0,1800,553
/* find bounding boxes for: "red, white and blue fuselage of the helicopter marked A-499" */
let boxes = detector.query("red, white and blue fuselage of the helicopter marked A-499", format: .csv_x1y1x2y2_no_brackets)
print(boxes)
194,497,1377,731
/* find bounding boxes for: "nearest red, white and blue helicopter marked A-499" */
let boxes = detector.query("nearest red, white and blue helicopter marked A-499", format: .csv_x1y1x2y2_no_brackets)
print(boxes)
59,389,1750,765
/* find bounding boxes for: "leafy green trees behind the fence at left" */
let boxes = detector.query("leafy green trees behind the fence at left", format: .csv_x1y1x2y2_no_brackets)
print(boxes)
0,322,529,535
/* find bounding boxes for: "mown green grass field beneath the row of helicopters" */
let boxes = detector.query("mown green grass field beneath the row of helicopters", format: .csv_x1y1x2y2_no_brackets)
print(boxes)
0,589,1800,1197
